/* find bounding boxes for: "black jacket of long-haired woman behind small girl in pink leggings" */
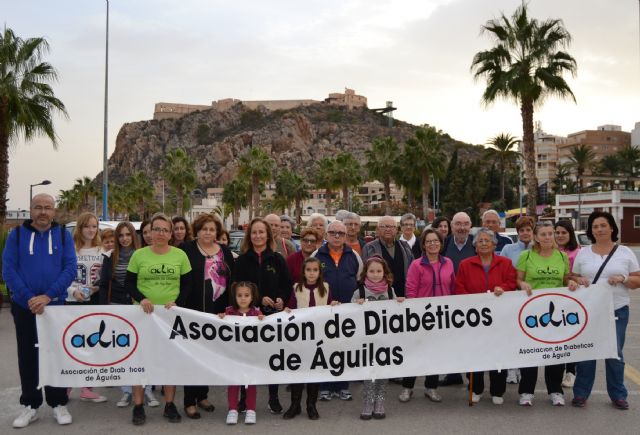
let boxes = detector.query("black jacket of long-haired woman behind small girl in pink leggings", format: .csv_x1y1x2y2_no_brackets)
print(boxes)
232,248,292,314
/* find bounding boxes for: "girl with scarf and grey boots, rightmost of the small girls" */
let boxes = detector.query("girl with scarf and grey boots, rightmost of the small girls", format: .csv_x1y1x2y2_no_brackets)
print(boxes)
351,255,404,420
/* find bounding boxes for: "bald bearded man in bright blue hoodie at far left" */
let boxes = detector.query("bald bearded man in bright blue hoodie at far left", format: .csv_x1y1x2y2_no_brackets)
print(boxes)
2,194,77,428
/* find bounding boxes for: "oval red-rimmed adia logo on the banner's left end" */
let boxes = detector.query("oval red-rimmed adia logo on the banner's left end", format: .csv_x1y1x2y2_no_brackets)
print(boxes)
62,313,138,367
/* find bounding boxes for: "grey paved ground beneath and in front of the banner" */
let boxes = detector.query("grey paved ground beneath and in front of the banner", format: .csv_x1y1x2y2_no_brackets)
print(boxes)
0,291,640,435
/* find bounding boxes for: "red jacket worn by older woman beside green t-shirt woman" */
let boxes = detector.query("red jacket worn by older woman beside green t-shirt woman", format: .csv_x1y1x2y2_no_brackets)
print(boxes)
455,254,516,295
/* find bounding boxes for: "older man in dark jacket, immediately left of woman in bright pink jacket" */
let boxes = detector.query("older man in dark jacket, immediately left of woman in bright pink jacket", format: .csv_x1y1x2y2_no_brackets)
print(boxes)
362,216,414,297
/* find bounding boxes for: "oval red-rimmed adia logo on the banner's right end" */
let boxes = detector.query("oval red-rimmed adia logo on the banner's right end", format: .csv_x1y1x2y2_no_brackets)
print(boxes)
518,293,589,344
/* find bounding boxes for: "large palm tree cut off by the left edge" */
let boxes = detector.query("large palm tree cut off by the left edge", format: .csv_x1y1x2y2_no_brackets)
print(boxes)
0,27,67,226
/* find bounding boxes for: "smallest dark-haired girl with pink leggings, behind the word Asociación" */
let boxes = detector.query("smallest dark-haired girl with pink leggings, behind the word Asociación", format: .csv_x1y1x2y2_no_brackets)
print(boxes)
218,281,264,424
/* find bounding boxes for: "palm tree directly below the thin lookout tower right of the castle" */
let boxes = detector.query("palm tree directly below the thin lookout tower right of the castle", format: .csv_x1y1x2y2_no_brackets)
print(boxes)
365,137,400,215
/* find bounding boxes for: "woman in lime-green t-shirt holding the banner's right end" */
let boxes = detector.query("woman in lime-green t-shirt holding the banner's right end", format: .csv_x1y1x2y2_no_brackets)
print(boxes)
516,221,578,406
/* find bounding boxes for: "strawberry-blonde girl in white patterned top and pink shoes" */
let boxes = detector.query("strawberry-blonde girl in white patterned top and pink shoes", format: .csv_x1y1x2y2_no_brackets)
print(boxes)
65,212,107,403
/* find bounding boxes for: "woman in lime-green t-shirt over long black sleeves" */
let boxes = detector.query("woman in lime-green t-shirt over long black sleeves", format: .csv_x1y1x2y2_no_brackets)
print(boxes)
125,213,191,425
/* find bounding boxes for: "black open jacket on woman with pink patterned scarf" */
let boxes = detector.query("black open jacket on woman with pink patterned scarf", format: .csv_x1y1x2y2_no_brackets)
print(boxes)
180,240,234,314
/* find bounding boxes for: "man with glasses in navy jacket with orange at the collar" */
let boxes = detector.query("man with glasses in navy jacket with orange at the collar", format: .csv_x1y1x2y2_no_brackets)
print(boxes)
313,221,362,402
